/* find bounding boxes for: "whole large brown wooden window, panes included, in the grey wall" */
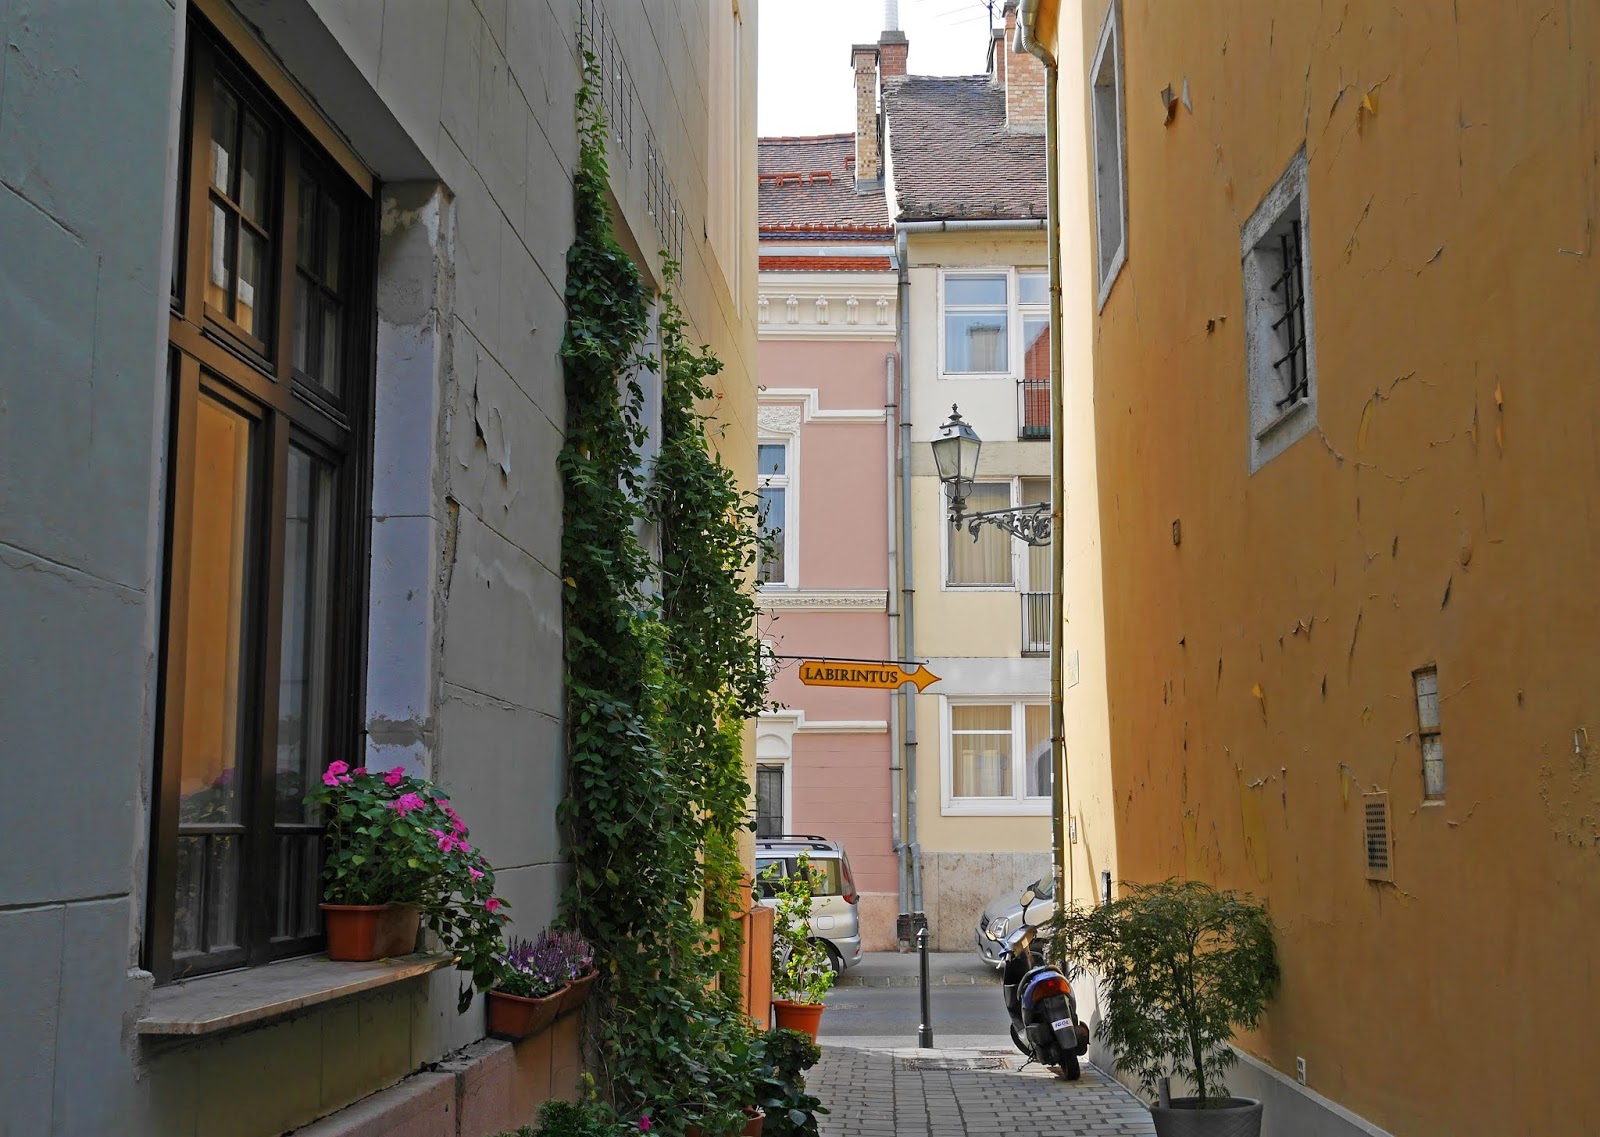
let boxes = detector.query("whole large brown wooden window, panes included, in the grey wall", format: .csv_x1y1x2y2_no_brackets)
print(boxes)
144,18,374,982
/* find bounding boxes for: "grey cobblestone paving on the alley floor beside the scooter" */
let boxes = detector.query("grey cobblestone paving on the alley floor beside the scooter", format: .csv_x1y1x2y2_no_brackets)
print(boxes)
806,1044,1155,1137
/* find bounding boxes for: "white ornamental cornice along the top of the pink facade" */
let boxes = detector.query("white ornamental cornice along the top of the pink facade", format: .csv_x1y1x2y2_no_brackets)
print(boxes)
755,272,898,341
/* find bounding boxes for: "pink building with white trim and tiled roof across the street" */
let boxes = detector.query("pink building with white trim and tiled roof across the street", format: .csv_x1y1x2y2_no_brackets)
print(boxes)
757,134,899,951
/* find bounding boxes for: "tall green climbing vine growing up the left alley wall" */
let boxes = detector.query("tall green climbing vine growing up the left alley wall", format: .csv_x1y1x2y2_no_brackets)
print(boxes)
560,31,766,1134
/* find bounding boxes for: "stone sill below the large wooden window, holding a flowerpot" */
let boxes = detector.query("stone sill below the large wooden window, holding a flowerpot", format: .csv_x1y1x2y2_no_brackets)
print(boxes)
139,951,453,1038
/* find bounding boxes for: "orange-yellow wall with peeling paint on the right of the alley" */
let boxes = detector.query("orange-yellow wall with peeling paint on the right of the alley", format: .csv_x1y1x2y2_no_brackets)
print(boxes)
1062,0,1600,1137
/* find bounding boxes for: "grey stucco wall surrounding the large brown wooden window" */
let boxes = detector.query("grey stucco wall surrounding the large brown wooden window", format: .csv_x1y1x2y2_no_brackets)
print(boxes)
0,0,754,1137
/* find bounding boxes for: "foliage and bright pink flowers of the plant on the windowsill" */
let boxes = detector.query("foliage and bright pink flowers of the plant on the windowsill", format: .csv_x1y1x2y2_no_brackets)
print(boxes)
306,761,509,1012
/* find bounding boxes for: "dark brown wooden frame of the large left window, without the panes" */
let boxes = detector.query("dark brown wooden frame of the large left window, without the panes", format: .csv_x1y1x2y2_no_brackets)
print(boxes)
142,14,378,983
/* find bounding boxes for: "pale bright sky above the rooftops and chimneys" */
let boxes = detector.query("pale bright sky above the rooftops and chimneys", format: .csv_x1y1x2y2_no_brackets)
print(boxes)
755,0,1000,138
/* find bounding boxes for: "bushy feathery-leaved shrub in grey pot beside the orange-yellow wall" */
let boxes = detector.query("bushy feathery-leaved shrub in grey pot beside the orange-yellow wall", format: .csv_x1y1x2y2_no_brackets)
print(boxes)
1053,880,1278,1137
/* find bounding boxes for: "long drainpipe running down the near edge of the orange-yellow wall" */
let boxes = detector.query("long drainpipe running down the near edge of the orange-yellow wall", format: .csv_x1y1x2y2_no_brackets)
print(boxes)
1016,0,1075,910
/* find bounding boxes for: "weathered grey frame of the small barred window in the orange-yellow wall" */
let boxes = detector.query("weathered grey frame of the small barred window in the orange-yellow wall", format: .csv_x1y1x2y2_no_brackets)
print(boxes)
1238,146,1317,473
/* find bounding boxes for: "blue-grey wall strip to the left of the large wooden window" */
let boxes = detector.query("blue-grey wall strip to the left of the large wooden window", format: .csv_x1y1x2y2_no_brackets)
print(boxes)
0,0,174,1137
